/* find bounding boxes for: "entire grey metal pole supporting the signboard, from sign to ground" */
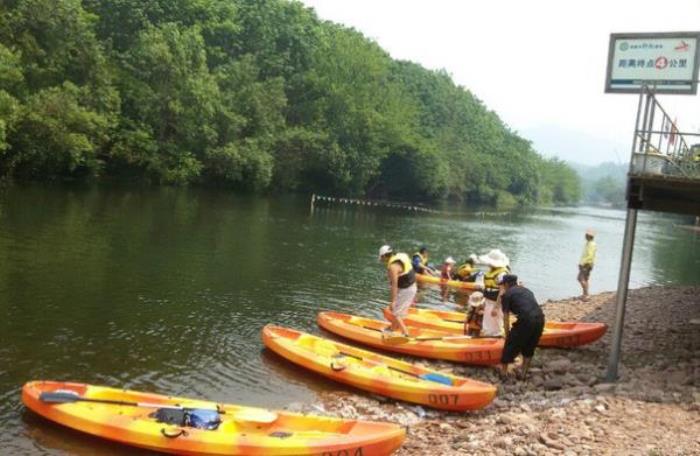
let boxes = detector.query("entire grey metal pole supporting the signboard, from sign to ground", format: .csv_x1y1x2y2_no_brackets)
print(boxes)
605,88,650,382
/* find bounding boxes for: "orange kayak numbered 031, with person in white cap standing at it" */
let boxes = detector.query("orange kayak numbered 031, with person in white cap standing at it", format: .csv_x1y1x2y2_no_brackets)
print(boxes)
317,312,503,365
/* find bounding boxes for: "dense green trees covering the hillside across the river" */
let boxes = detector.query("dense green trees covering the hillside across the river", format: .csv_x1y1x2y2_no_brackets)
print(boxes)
0,0,580,203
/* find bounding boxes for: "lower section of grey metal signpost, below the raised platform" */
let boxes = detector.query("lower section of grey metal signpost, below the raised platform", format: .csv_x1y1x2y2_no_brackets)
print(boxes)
605,209,637,382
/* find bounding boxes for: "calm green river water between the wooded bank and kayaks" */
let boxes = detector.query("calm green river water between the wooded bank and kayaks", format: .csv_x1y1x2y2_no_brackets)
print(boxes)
0,185,700,455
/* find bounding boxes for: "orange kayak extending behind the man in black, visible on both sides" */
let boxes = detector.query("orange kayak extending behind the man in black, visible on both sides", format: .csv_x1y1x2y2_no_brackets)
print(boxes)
404,308,608,348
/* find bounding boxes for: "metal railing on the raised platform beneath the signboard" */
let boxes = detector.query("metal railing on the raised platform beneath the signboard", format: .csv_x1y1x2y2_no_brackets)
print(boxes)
630,87,700,179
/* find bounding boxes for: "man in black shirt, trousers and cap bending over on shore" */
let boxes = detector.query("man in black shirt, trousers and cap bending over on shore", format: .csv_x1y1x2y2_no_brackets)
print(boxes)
499,274,544,380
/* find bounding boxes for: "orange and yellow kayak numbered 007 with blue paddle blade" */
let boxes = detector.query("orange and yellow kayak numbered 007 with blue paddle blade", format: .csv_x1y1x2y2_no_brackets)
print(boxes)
262,325,496,411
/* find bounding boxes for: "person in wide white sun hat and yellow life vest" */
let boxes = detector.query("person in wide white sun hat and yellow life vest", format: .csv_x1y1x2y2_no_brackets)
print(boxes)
477,249,510,337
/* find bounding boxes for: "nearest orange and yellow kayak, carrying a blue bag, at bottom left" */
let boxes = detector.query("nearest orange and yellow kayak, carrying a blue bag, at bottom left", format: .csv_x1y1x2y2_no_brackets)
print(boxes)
22,381,405,455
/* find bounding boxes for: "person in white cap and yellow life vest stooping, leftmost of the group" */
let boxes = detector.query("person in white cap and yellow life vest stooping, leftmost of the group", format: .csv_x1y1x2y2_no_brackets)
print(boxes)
379,245,418,336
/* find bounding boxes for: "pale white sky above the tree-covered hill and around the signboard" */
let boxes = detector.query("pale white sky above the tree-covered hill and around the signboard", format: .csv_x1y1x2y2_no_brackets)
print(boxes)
302,0,700,165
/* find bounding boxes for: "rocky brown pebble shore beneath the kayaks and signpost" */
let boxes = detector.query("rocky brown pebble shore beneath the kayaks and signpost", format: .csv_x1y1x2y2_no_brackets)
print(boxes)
288,287,700,456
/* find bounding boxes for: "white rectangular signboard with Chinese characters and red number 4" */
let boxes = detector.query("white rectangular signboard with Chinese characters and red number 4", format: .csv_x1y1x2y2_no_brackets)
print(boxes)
605,32,700,95
